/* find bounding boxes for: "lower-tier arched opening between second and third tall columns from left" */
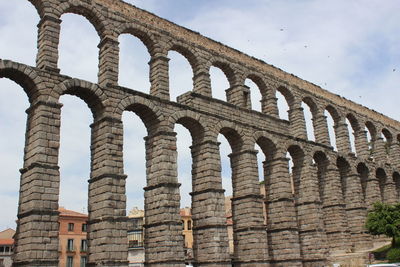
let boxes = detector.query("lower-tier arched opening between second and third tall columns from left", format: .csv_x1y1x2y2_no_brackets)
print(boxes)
122,104,158,264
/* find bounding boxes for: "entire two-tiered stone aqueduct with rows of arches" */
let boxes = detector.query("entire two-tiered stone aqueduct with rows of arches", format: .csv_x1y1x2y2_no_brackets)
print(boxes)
0,0,400,267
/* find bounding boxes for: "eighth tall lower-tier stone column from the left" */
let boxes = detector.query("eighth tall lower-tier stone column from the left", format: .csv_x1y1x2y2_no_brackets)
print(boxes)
322,163,351,253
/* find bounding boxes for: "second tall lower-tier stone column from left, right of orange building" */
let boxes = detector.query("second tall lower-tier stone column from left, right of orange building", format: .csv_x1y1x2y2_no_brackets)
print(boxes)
88,117,128,267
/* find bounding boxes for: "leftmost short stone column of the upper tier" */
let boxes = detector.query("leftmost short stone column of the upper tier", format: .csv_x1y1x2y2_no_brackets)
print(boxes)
36,15,61,72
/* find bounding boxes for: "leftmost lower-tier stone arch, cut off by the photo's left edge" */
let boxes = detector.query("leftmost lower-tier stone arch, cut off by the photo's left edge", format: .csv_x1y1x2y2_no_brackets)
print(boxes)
0,59,44,104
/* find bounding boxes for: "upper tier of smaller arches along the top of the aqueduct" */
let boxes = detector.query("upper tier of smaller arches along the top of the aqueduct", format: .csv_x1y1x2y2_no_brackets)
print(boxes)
7,0,400,171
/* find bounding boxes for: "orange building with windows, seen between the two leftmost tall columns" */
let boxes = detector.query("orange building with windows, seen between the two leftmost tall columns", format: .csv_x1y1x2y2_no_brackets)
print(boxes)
58,207,88,267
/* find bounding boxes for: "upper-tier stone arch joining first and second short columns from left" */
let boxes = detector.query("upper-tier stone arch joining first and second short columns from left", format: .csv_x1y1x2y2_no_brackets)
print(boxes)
56,0,112,40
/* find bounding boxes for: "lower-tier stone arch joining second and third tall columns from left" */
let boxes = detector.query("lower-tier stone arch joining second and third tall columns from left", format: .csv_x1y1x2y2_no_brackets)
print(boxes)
113,96,162,134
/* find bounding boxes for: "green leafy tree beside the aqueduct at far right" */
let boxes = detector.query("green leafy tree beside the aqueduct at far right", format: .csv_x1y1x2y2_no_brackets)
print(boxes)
365,202,400,247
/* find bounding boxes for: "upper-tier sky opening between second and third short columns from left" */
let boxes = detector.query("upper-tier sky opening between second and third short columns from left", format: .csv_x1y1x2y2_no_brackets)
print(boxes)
118,33,151,93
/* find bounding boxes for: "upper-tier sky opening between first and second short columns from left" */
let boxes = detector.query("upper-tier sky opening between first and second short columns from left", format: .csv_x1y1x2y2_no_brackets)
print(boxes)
58,14,100,83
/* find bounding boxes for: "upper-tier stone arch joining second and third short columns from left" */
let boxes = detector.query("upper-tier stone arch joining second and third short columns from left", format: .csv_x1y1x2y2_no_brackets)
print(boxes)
115,23,156,56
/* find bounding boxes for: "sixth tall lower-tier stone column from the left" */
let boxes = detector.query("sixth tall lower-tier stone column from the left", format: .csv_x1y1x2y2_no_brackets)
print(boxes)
264,157,303,267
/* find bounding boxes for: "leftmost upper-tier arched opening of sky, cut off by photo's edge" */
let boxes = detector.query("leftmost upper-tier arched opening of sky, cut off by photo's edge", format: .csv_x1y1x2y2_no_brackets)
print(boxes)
0,1,40,66
